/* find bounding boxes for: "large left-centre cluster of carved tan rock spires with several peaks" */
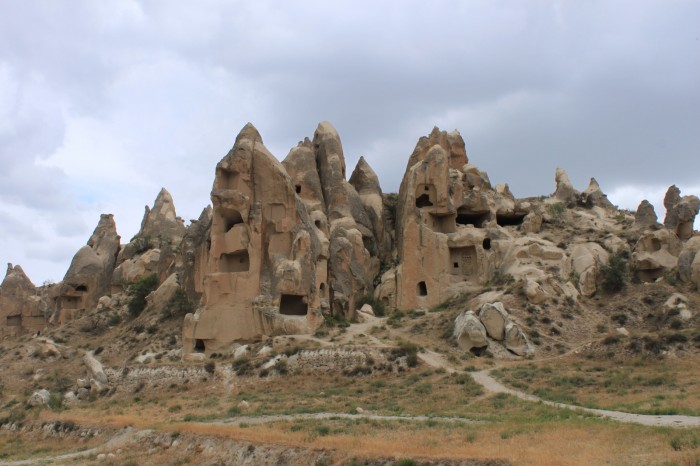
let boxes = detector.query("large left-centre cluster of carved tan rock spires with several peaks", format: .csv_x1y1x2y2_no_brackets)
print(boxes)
183,122,387,353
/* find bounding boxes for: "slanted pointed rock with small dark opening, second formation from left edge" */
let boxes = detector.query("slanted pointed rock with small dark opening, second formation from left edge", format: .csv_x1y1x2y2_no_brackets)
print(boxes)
51,214,119,323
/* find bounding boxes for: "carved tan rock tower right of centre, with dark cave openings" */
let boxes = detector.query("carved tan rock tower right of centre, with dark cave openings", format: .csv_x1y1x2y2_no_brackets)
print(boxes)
388,128,528,309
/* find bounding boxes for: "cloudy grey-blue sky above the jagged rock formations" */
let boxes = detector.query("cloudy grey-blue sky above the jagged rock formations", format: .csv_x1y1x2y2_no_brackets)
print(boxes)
0,0,700,285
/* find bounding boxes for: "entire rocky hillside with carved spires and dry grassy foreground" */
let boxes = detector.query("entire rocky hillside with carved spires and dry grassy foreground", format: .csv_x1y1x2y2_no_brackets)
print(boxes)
0,122,700,465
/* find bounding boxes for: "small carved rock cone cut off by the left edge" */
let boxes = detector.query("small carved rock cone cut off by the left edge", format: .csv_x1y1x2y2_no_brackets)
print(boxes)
0,264,48,339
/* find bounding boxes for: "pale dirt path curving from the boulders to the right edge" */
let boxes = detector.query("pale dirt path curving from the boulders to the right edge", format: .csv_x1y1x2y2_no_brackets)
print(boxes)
418,351,700,427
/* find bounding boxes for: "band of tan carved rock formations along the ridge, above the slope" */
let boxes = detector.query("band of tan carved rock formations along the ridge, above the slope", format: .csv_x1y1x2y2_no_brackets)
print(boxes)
0,122,700,353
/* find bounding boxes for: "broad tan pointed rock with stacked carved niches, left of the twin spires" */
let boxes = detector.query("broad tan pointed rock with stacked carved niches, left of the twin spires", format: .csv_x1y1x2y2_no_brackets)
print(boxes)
183,124,328,353
